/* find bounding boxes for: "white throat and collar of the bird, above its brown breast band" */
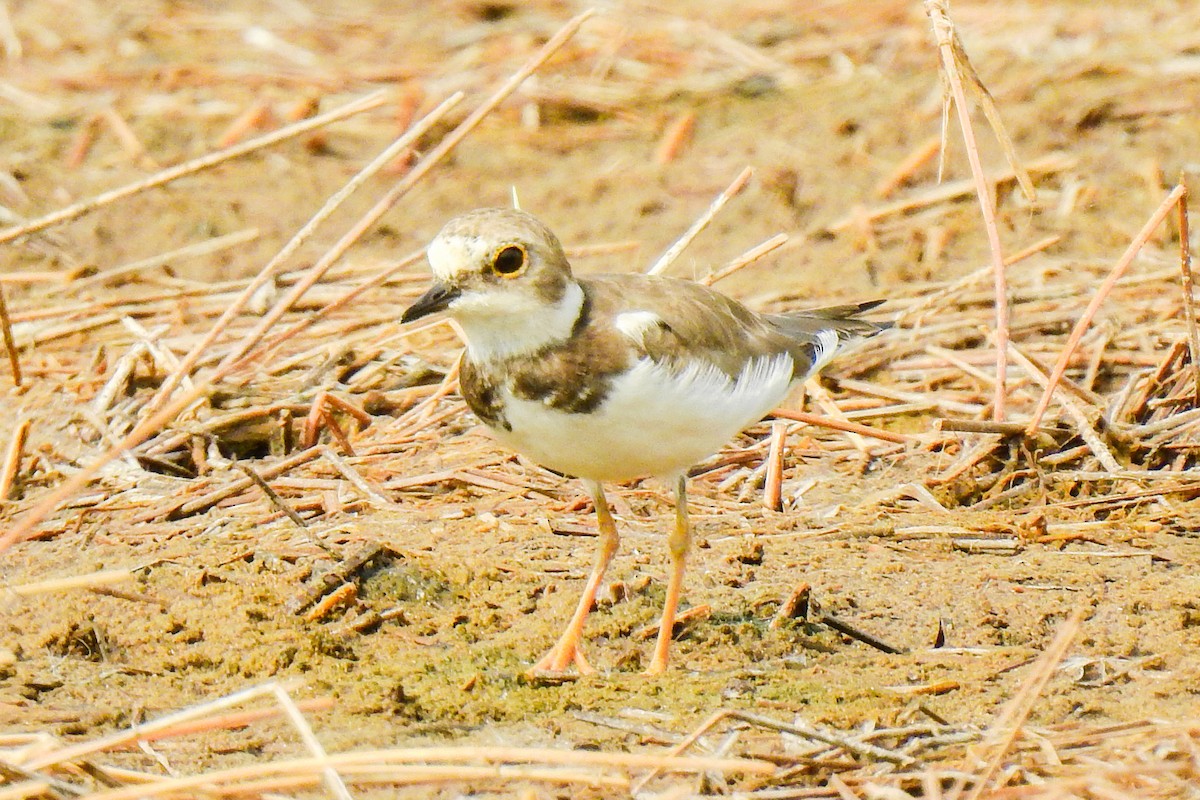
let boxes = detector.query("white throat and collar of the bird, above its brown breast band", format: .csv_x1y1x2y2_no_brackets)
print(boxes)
452,281,583,363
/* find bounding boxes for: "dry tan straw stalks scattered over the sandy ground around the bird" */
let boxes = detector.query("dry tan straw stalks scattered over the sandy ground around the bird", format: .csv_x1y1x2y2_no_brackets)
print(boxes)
0,1,1200,800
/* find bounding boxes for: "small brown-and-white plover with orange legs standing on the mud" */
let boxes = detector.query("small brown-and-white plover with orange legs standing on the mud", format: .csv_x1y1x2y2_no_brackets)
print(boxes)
401,207,887,676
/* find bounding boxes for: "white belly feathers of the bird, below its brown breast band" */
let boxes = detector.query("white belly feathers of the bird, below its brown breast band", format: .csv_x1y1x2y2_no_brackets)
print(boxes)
494,353,793,481
